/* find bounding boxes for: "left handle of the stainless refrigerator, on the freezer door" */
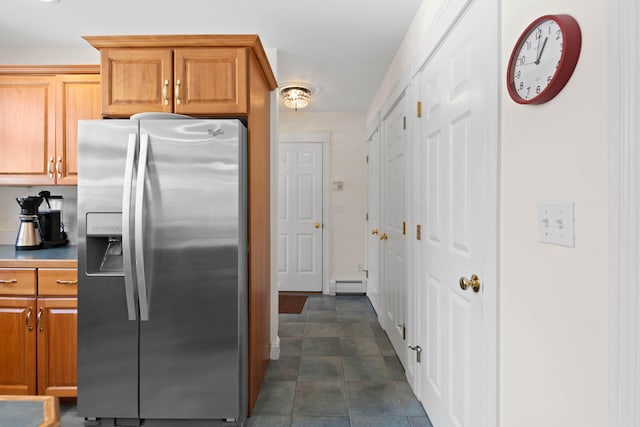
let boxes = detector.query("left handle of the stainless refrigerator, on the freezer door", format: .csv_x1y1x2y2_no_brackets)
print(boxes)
122,133,138,320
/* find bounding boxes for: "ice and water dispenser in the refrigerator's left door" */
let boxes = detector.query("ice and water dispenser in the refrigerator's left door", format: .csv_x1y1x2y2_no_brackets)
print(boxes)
87,212,124,276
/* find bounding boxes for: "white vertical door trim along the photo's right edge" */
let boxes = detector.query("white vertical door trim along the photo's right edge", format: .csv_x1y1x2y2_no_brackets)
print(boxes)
608,0,640,427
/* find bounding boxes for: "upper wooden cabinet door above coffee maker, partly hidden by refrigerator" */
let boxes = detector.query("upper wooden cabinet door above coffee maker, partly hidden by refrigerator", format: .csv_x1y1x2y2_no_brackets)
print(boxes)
55,74,101,185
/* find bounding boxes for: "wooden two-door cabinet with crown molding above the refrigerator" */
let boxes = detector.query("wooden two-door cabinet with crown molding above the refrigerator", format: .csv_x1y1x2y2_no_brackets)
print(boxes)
85,35,276,117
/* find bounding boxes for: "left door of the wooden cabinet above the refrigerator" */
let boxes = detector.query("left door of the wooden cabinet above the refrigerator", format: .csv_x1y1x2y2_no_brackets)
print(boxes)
100,48,173,117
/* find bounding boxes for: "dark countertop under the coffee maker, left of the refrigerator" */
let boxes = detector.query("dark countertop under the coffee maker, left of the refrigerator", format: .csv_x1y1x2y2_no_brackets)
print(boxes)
0,245,78,267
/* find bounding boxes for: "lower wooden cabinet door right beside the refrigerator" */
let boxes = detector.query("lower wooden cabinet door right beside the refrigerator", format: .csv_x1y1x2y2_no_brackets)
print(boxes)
36,298,78,397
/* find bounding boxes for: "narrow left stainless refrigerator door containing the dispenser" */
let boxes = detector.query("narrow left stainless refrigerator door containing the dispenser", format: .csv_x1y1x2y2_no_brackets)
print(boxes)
78,120,138,418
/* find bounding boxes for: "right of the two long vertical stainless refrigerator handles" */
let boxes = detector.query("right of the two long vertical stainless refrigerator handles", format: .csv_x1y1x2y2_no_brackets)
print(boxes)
134,133,149,321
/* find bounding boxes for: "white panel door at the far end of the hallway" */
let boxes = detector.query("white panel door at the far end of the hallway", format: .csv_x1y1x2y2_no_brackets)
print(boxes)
278,142,323,292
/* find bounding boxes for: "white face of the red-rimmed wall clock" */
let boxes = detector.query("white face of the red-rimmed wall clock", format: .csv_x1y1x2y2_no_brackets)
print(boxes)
513,19,563,101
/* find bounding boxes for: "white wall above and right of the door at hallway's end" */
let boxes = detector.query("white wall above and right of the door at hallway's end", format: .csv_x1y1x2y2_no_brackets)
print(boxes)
278,111,366,280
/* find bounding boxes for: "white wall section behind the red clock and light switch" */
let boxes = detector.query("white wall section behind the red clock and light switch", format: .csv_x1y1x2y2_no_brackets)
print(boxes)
500,0,608,427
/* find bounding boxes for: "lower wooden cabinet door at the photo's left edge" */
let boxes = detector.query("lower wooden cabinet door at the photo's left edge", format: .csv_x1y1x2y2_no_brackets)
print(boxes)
0,298,36,394
